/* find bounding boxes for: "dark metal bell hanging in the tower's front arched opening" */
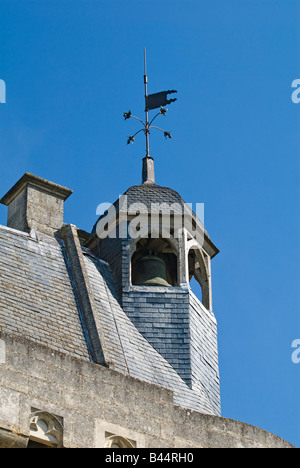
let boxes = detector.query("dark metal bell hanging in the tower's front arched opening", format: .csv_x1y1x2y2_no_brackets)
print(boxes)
133,255,171,286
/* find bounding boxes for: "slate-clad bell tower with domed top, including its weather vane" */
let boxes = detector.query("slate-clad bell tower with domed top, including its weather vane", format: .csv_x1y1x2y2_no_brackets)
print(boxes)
86,52,220,415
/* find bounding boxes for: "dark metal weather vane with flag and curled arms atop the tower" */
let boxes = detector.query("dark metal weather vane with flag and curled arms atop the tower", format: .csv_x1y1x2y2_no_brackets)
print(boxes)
123,49,177,158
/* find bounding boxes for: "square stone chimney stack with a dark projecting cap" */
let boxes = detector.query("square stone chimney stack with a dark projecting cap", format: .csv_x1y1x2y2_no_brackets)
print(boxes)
0,173,73,235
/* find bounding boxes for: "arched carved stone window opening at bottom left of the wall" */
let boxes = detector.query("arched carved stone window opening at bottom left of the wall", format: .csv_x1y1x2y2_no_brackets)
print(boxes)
28,411,63,448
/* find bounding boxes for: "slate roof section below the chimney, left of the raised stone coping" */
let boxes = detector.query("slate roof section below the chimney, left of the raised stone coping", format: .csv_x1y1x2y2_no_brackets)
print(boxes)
0,226,89,359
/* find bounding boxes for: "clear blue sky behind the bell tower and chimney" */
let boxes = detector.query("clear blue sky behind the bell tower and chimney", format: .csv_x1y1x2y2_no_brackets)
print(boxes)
0,0,300,447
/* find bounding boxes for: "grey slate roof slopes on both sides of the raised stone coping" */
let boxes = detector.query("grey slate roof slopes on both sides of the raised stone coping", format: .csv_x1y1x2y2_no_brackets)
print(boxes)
0,226,214,414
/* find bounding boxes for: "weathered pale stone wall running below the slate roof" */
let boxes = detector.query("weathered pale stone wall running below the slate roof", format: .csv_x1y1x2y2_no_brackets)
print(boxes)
0,333,291,448
